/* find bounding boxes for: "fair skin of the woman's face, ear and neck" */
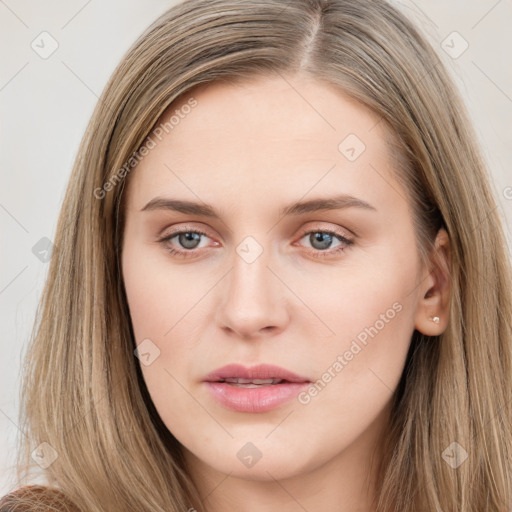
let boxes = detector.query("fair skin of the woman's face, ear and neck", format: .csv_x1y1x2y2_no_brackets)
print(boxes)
122,75,449,512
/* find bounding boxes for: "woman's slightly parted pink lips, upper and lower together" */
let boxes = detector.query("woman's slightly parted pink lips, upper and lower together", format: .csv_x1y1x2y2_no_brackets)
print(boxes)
204,364,311,413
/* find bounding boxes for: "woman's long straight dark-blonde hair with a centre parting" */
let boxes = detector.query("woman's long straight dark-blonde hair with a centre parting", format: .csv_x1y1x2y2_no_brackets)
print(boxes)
8,0,512,512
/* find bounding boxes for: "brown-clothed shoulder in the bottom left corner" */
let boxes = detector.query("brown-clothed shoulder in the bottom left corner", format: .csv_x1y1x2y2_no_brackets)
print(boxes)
0,485,78,512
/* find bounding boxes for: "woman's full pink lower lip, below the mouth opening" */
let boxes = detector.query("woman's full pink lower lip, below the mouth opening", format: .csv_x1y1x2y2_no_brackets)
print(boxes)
206,382,309,412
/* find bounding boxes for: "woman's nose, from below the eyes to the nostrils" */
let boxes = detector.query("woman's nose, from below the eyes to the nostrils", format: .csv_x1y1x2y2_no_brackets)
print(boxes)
217,241,289,339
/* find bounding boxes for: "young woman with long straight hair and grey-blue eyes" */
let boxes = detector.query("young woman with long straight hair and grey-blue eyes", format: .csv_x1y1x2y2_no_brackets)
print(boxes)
1,0,512,512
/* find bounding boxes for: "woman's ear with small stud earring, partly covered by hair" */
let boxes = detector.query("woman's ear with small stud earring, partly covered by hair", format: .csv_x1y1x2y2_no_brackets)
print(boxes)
414,228,451,336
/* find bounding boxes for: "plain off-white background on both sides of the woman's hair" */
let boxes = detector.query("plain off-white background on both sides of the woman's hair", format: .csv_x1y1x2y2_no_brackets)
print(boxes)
0,0,512,495
